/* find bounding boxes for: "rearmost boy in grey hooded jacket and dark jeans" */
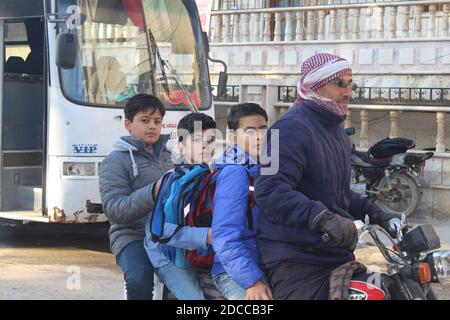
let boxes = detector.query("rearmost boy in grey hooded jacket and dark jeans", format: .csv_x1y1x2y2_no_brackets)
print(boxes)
99,94,172,300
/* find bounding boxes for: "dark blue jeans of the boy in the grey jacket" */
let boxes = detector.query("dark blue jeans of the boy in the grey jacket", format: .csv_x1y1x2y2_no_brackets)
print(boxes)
116,241,153,300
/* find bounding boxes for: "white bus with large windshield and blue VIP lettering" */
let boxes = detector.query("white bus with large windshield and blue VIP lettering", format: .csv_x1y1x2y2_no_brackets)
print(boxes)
0,0,225,223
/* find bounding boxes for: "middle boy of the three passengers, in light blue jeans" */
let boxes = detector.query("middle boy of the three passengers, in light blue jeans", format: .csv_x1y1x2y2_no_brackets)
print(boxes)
144,113,216,300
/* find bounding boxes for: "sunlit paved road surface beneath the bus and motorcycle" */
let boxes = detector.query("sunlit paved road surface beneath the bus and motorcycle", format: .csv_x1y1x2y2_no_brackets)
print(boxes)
0,221,450,300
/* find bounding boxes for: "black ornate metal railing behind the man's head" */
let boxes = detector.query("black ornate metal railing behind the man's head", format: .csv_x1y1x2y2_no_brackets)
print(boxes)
278,86,450,107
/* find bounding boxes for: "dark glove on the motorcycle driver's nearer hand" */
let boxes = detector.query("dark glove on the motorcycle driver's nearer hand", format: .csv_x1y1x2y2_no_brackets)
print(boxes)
310,210,358,251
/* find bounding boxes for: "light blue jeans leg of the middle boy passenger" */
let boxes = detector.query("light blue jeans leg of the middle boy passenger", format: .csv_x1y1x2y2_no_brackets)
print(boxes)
155,262,205,300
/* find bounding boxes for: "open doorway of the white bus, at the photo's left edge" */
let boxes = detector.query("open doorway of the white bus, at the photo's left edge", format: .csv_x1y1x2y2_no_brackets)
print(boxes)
0,17,47,221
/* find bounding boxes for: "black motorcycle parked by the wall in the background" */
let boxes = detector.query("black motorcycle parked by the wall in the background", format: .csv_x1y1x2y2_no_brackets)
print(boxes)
346,128,434,217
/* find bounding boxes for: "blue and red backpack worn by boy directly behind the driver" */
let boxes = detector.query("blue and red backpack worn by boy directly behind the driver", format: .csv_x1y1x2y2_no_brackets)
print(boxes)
150,163,255,268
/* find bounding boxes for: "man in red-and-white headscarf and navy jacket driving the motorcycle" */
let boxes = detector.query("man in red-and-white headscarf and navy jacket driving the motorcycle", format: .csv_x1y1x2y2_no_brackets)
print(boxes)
255,53,400,299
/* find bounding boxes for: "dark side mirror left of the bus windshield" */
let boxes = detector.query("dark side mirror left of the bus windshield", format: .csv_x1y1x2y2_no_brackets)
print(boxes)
56,32,78,69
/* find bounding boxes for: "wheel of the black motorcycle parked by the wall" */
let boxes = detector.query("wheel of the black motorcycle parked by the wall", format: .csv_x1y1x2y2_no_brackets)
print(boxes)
376,172,420,217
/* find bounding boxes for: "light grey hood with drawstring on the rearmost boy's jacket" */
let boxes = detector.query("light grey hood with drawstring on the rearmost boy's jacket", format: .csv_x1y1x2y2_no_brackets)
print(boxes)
112,134,170,177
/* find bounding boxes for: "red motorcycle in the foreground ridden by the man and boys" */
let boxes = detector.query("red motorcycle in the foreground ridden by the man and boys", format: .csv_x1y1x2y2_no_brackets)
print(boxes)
349,215,450,300
